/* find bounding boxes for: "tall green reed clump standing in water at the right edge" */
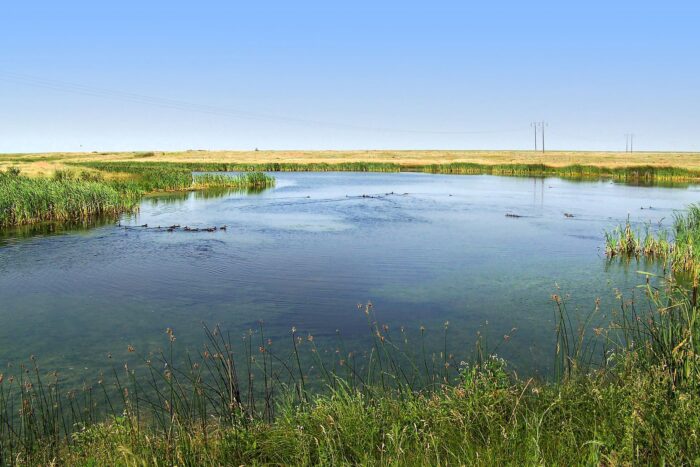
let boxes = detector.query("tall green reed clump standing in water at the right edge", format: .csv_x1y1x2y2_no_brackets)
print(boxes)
606,204,700,394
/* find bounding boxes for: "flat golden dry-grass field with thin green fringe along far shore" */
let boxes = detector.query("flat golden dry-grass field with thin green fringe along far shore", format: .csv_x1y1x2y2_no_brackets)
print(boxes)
0,150,700,181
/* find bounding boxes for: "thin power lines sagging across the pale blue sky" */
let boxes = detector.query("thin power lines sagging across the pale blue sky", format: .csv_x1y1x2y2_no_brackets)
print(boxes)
0,70,525,135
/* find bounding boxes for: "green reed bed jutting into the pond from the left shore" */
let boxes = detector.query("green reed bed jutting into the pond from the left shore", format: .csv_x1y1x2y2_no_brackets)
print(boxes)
0,167,274,228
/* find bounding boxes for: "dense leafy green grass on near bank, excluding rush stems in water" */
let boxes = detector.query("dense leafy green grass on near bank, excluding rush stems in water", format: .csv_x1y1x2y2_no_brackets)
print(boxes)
12,364,700,466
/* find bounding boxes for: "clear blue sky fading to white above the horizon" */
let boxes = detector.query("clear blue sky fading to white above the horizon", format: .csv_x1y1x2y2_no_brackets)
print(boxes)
0,0,700,153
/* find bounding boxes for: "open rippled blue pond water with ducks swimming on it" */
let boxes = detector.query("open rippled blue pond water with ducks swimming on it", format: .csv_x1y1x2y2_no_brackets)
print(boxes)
0,173,700,374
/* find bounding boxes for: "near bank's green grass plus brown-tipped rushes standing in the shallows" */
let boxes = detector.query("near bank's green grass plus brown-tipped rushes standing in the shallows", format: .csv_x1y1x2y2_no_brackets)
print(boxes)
0,282,700,465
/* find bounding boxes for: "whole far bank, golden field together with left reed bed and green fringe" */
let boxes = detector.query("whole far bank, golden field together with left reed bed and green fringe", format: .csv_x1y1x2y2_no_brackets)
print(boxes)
0,151,700,228
